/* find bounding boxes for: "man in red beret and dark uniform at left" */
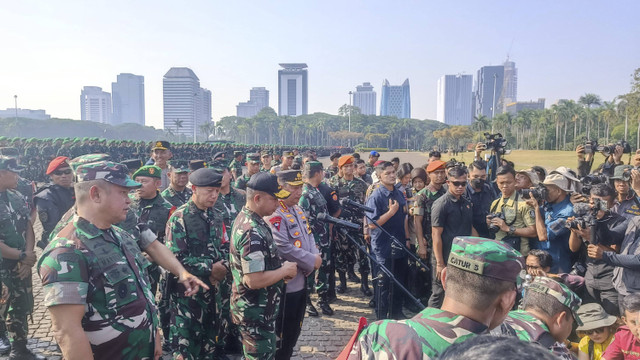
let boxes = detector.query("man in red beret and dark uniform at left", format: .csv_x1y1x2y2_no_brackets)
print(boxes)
34,156,76,249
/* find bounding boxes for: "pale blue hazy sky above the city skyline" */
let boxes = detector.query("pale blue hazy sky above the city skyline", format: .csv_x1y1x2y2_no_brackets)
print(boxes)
0,0,640,127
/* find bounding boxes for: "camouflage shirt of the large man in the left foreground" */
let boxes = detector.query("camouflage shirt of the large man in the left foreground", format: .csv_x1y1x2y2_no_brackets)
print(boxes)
38,215,158,360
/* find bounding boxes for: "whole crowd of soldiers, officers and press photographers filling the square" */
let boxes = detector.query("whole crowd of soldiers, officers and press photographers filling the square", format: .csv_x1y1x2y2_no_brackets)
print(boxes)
0,139,640,359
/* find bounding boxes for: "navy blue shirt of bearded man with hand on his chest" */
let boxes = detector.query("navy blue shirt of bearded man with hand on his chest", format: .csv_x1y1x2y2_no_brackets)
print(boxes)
367,186,407,261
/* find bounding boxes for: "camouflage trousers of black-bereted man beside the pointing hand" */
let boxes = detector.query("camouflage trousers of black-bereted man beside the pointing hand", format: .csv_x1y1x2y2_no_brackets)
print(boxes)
169,289,220,360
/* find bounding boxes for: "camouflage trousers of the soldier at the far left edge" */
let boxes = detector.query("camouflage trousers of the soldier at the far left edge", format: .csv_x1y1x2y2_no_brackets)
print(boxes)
0,265,33,341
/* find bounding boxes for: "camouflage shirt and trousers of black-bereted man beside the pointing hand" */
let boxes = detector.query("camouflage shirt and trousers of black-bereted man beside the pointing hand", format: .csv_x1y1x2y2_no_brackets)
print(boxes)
166,200,225,359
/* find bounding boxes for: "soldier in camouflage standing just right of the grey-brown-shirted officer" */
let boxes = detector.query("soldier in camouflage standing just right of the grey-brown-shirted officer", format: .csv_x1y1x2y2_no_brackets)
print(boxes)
299,161,333,315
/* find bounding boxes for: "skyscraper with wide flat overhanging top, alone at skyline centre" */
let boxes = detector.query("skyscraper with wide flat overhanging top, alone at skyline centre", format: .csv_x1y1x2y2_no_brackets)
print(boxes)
278,63,308,116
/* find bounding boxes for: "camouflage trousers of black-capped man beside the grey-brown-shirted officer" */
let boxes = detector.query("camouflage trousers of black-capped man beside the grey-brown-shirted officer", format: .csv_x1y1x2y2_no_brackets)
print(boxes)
238,324,276,360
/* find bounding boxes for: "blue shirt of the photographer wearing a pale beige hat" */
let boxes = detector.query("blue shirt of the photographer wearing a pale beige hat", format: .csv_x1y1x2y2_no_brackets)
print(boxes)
539,195,575,274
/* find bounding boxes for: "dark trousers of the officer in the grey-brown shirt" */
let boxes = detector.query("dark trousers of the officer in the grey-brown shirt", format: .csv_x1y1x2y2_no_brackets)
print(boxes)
276,286,308,360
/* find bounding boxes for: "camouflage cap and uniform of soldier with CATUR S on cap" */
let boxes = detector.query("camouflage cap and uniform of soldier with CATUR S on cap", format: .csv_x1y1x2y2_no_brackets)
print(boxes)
349,237,525,360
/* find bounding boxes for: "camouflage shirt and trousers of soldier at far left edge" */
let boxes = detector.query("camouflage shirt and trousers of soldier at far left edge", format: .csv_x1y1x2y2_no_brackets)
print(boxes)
0,190,33,343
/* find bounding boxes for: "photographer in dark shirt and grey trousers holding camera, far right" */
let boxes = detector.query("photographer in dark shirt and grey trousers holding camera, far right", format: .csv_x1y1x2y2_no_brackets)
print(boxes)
567,184,628,316
